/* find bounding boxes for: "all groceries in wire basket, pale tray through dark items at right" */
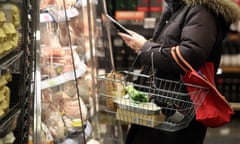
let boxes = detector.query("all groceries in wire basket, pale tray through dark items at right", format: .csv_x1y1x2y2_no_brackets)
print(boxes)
115,84,184,127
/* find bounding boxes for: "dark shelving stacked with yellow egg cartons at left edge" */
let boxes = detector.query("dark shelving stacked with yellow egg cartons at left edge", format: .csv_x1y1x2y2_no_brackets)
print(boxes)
0,0,33,144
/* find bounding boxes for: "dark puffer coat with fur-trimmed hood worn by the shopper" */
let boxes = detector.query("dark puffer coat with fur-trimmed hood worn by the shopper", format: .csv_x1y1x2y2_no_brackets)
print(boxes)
140,0,240,79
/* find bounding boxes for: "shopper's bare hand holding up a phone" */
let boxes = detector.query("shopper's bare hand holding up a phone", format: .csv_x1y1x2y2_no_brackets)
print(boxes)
118,30,147,52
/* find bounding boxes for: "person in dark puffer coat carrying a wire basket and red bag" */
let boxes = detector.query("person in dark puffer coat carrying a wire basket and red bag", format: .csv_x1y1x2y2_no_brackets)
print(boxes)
119,0,240,144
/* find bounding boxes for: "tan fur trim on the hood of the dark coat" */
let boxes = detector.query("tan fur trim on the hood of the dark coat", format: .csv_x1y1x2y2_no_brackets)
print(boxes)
182,0,240,23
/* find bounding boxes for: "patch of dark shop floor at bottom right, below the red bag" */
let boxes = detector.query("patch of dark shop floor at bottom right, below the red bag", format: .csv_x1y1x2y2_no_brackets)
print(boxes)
204,112,240,144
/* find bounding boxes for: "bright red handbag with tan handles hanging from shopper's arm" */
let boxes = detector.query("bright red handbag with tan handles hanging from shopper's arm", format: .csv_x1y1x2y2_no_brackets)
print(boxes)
171,46,234,128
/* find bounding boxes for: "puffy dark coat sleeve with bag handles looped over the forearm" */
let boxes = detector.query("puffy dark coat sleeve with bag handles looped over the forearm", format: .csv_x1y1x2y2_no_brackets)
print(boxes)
140,6,217,73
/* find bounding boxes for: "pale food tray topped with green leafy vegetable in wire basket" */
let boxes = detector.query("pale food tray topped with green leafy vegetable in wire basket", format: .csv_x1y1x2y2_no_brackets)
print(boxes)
115,84,165,127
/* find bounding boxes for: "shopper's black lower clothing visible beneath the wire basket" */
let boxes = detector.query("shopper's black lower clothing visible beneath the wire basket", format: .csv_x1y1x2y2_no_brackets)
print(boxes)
125,120,207,144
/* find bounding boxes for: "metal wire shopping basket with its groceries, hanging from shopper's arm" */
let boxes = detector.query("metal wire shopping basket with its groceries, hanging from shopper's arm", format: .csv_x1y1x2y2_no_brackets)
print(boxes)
97,71,208,131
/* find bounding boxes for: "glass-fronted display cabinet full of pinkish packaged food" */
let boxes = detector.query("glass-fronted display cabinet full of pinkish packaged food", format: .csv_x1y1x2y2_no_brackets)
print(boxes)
29,0,124,144
